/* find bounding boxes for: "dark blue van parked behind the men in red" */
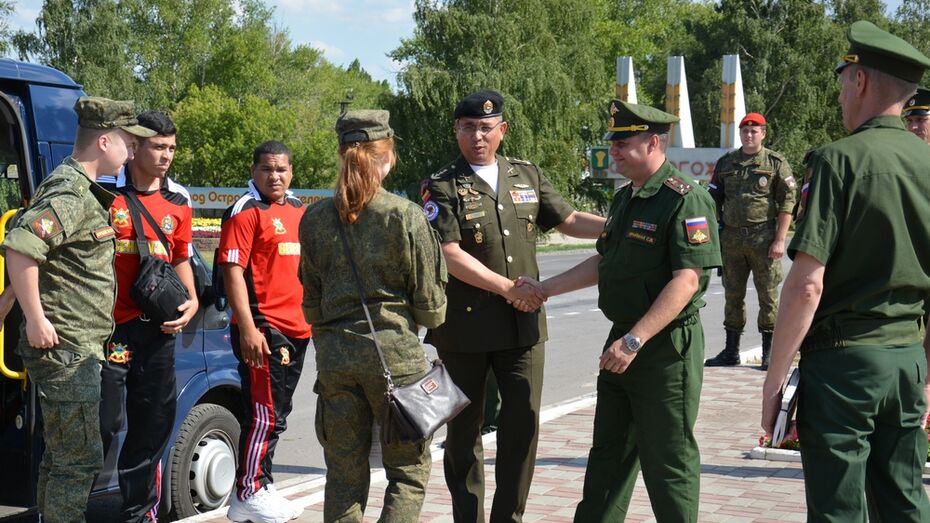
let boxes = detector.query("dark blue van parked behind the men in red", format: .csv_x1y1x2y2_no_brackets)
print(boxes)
0,59,242,522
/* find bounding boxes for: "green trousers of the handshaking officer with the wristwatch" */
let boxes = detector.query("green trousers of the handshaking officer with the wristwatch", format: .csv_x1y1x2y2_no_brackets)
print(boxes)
575,322,704,523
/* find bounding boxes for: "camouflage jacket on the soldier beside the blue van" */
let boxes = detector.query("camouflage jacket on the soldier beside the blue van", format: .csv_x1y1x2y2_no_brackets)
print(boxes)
2,157,116,360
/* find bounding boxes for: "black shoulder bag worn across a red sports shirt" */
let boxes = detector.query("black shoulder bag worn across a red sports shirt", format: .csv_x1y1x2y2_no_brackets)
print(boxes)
123,187,190,324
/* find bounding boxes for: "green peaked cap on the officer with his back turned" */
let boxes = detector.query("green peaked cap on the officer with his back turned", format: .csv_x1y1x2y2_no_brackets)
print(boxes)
835,20,930,83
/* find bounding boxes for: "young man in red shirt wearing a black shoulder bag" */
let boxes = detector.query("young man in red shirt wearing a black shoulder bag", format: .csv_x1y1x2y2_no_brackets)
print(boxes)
99,111,198,523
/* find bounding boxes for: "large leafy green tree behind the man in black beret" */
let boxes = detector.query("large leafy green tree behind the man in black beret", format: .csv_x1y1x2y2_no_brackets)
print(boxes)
388,0,607,205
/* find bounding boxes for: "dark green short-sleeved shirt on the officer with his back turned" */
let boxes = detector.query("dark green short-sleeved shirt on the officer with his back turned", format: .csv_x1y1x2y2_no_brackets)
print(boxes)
788,116,930,351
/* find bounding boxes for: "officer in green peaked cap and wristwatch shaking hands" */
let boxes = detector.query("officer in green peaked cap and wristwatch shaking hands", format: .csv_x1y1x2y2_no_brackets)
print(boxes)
528,100,720,523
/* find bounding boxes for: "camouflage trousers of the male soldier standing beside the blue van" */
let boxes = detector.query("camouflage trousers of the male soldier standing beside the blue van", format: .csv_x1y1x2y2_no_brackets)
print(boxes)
19,344,103,523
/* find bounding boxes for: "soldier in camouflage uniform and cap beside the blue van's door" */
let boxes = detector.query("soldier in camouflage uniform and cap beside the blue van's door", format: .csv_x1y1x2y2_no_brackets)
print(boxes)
2,97,155,523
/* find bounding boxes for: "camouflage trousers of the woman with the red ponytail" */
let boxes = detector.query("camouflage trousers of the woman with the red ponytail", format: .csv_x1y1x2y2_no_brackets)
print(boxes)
314,370,433,523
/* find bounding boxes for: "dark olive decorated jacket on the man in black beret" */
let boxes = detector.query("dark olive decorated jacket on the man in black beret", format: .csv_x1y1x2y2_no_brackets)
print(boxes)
422,155,573,352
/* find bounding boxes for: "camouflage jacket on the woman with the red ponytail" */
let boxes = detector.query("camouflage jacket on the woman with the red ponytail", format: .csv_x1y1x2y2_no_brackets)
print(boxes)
299,189,447,374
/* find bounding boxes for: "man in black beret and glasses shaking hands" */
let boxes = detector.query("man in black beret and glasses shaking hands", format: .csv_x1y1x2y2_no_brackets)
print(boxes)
422,91,604,523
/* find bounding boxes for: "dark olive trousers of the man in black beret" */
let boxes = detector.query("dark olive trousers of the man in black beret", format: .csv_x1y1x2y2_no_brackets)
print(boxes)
439,343,545,523
